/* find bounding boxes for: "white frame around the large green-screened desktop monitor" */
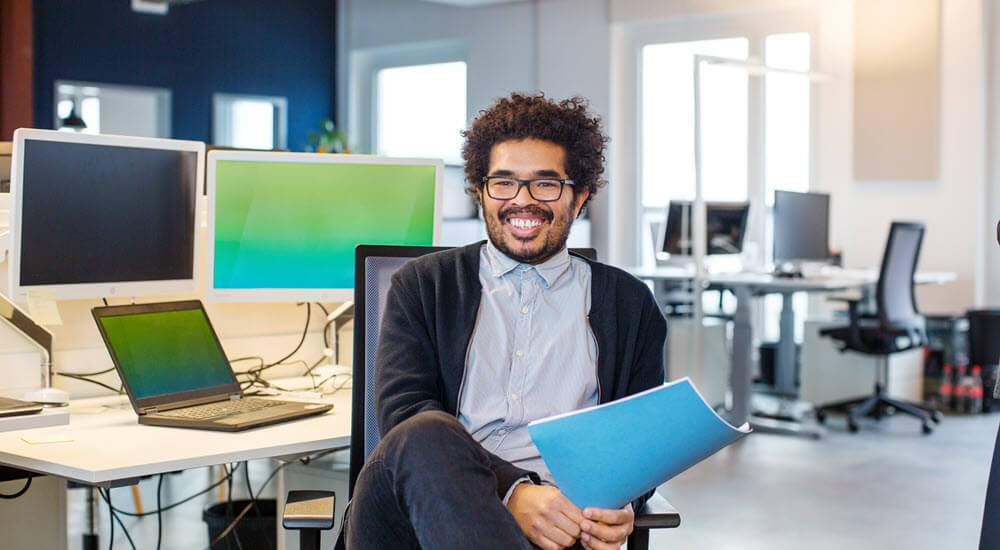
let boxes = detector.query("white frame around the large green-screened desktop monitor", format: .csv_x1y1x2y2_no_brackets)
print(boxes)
205,150,444,302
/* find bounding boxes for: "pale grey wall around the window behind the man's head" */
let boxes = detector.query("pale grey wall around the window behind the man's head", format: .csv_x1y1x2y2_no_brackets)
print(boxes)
337,0,617,258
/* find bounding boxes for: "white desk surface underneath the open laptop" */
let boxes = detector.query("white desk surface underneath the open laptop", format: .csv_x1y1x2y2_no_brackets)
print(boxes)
0,386,351,485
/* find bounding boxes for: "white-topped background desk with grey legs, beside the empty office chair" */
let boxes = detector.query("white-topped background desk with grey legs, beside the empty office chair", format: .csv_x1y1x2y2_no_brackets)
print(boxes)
626,267,955,437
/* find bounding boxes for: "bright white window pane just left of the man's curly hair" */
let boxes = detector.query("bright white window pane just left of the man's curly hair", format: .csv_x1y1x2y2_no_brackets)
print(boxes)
374,61,466,164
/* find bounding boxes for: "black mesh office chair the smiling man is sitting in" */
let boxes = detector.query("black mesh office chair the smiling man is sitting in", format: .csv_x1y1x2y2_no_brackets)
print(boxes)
348,245,680,550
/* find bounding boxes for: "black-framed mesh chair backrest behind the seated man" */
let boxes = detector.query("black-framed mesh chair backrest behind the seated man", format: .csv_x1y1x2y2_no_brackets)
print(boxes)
348,245,597,493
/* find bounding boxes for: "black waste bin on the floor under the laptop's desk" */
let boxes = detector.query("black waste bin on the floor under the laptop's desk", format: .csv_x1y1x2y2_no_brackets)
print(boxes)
202,499,278,550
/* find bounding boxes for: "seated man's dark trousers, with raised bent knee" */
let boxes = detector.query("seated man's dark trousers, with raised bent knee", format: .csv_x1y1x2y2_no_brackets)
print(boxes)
343,411,532,550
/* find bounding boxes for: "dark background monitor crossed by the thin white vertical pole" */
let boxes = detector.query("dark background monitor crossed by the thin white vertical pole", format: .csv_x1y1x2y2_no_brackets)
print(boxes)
661,201,750,256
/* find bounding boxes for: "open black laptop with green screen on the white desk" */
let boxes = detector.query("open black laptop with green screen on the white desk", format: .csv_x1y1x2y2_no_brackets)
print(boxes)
92,300,333,431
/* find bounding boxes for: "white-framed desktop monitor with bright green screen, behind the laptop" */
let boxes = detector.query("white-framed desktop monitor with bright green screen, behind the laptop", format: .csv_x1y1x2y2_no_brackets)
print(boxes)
205,151,444,302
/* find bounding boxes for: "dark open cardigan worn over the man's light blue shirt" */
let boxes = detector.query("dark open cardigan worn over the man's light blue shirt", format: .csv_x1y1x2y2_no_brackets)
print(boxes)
374,241,667,511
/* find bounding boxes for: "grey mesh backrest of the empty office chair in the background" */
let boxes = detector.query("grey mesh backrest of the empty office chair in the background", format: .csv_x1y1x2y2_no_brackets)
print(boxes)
876,222,924,327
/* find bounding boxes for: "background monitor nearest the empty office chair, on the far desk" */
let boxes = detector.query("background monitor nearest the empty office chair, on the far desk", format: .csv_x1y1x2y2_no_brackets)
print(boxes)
772,191,830,264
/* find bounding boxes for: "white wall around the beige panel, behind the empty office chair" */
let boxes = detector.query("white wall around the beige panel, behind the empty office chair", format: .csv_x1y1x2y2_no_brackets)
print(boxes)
816,0,986,312
